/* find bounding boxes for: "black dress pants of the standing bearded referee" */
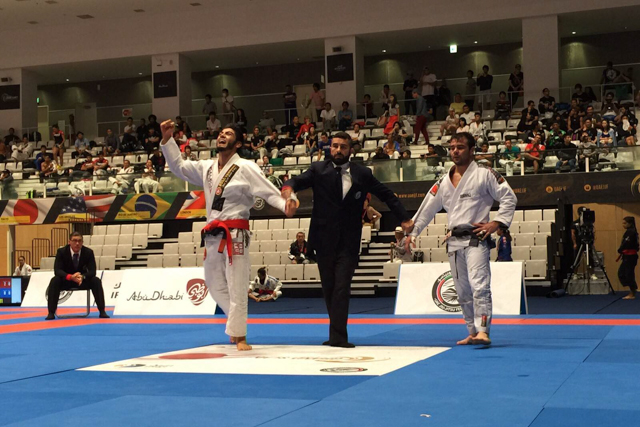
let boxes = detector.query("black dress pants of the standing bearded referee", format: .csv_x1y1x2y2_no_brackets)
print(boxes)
316,245,358,344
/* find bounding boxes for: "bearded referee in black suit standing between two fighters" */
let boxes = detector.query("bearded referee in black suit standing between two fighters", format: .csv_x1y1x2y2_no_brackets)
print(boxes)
282,132,413,348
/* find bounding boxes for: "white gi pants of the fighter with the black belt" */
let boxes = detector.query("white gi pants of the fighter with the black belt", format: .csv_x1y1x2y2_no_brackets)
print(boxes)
449,242,492,335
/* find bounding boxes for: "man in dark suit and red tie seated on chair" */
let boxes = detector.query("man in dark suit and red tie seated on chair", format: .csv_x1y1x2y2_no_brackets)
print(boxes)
46,231,109,320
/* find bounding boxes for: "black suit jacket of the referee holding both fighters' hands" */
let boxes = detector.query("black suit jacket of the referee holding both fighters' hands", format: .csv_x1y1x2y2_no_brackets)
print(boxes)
284,160,411,256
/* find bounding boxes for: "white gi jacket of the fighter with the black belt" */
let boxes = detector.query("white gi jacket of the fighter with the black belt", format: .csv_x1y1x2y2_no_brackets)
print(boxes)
411,162,518,252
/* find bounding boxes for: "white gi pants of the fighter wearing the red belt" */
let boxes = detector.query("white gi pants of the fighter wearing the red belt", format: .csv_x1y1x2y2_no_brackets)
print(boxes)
204,230,251,337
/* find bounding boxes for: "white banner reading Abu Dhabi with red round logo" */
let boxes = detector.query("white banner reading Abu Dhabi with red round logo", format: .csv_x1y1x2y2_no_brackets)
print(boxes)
114,267,215,316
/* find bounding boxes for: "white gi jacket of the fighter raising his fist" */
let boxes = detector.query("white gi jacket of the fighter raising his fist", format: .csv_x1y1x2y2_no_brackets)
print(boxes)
160,138,285,222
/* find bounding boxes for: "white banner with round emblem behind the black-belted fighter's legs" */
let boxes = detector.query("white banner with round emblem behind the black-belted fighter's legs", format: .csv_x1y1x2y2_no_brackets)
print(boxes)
395,262,527,315
